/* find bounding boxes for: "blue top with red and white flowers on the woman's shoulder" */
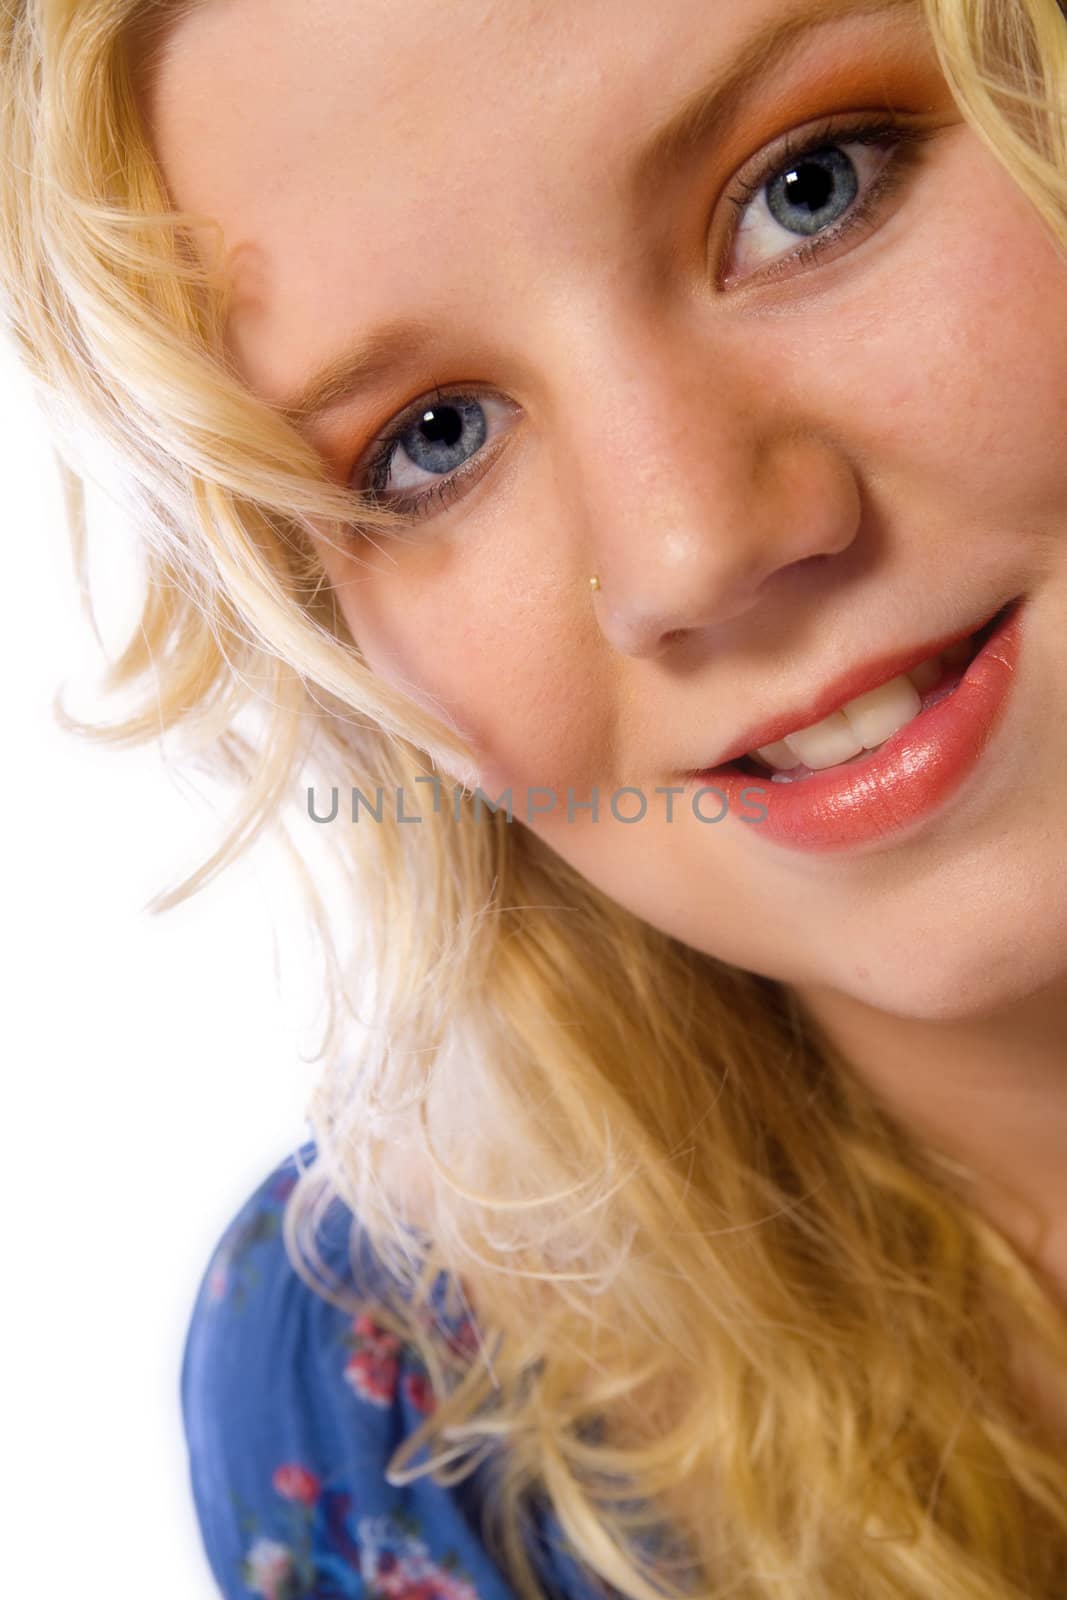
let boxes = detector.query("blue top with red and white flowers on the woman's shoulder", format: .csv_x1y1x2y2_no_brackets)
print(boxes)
181,1142,614,1600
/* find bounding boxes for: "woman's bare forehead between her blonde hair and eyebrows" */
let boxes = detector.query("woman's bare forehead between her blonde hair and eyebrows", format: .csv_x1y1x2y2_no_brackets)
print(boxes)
147,0,918,422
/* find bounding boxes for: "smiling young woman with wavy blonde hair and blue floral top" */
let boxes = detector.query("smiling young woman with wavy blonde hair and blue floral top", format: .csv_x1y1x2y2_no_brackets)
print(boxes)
0,0,1067,1600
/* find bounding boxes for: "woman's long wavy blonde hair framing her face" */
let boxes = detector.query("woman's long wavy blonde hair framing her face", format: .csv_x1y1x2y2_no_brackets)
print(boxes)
0,0,1067,1600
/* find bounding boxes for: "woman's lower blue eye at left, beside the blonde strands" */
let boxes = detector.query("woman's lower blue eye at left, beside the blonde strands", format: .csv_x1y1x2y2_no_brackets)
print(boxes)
362,389,517,518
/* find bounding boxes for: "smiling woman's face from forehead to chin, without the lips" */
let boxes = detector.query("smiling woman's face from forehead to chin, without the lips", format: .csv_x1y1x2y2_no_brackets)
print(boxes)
150,0,1067,1019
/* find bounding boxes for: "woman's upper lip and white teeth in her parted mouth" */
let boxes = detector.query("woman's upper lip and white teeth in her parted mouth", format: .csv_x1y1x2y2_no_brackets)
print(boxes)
699,597,1021,784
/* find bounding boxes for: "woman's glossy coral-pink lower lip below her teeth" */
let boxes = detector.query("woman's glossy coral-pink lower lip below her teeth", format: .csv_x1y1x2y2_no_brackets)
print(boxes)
696,602,1022,851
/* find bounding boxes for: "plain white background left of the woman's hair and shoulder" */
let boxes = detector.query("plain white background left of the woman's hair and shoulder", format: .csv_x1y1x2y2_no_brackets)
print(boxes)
0,336,326,1600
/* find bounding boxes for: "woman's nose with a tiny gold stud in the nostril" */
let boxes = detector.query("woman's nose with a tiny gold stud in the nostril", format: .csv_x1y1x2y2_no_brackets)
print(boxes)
571,337,859,656
